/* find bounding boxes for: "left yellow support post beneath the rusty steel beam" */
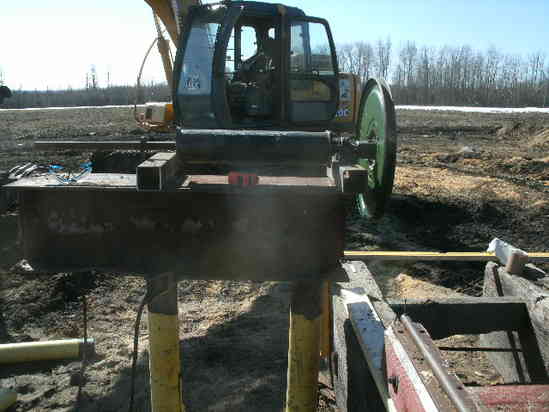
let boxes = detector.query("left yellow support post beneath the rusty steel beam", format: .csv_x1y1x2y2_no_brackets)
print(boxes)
147,276,185,412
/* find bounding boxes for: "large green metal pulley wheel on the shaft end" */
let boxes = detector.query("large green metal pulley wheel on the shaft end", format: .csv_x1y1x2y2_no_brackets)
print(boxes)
356,79,397,219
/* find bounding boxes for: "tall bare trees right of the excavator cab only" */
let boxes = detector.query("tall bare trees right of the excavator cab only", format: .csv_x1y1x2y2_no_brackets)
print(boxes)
338,38,549,107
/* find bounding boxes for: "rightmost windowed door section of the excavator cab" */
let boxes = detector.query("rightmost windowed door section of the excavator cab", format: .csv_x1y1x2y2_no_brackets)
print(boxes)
287,17,339,127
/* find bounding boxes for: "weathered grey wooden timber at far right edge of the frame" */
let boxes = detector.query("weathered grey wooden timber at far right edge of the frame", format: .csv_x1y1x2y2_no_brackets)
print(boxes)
480,263,549,383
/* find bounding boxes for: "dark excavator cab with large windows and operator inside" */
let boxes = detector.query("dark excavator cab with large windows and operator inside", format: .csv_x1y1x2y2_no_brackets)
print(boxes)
174,1,339,130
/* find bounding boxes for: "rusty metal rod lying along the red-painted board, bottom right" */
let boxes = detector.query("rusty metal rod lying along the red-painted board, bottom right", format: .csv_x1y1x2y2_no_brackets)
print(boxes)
400,315,477,412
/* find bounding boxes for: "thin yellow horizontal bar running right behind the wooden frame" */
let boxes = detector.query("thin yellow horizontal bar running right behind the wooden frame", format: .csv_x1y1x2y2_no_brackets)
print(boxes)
344,250,549,262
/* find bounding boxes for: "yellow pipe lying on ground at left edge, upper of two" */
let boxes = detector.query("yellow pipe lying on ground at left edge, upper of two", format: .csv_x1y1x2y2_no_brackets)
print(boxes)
0,338,94,364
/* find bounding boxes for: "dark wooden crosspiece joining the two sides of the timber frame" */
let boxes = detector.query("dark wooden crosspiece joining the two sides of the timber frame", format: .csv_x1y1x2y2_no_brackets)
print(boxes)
388,297,528,339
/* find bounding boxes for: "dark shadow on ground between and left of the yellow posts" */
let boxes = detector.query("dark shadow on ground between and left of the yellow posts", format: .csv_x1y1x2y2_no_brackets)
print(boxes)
73,283,289,412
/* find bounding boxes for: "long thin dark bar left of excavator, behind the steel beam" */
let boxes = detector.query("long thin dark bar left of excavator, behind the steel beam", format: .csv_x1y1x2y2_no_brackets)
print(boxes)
34,140,175,150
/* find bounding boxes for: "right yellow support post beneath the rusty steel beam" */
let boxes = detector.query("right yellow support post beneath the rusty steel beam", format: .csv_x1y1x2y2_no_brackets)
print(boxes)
285,281,322,412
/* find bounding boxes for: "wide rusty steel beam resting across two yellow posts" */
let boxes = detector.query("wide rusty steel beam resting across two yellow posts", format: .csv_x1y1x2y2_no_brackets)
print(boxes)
11,174,345,281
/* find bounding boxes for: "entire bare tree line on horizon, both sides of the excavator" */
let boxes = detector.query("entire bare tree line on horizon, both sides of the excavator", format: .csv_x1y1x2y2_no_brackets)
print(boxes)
4,38,549,108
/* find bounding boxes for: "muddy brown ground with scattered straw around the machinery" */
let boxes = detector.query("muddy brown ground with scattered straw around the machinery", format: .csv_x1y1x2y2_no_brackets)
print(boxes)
0,108,549,411
